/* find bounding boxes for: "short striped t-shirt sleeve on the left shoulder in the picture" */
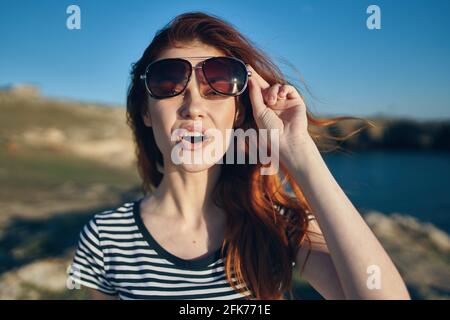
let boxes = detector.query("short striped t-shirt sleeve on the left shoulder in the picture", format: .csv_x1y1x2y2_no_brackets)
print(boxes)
68,217,117,295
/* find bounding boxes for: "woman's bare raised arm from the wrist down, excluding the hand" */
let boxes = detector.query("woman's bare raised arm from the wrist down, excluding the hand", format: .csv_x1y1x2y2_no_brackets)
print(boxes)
282,137,410,299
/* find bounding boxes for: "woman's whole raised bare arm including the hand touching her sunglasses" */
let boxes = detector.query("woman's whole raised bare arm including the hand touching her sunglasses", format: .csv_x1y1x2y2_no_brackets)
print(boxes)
248,66,409,299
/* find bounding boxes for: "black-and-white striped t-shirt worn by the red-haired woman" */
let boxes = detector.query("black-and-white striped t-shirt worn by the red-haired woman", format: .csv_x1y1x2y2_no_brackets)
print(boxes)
69,199,255,300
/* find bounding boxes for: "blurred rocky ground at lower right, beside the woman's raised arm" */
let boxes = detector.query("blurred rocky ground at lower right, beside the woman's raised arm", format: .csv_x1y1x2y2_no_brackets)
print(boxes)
364,211,450,299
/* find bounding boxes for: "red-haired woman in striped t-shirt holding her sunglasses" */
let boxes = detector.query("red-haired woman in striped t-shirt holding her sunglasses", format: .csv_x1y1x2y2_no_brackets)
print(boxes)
67,13,409,299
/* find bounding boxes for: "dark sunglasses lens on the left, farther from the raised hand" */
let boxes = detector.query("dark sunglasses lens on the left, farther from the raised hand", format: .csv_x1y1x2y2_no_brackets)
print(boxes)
146,59,191,98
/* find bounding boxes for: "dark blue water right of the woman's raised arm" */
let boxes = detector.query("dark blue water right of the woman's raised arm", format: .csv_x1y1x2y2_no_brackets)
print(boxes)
290,151,450,232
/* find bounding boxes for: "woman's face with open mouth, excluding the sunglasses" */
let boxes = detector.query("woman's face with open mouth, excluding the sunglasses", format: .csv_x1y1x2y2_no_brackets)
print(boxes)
144,42,243,172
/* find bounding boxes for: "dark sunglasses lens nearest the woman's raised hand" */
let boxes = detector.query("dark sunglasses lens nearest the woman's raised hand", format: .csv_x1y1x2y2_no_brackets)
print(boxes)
203,57,247,95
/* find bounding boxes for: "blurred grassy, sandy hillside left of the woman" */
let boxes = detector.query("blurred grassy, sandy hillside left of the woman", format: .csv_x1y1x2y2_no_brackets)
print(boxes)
0,89,140,222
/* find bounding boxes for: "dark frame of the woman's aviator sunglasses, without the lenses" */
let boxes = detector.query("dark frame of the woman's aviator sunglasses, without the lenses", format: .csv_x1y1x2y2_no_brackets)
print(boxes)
139,56,252,100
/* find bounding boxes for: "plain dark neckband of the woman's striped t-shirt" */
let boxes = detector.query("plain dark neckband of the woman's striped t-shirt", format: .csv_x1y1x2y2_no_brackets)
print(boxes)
133,198,222,269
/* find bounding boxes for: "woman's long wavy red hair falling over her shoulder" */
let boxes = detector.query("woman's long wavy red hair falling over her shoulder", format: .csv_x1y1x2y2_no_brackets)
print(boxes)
127,12,372,299
